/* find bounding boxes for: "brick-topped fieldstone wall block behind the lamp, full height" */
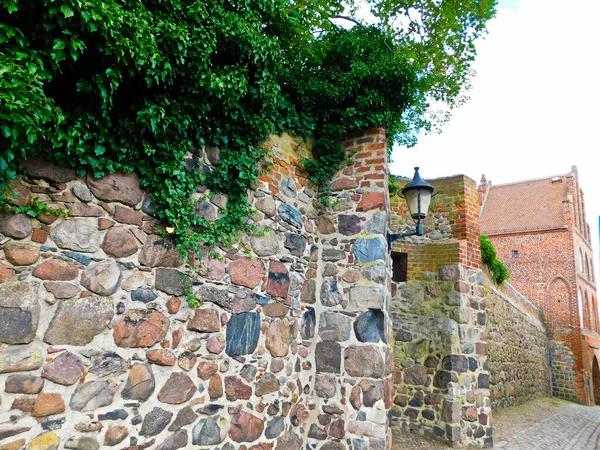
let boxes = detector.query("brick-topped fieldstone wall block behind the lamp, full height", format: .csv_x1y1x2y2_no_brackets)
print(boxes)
391,176,493,448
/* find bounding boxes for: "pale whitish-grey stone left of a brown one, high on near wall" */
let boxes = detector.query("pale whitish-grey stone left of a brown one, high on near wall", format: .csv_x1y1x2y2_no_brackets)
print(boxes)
50,218,101,253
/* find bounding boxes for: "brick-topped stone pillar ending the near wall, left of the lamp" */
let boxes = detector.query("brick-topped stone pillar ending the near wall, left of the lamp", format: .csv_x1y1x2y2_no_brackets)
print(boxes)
308,128,393,450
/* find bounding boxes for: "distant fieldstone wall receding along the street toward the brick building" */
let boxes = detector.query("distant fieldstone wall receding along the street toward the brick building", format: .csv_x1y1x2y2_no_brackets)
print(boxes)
485,276,550,411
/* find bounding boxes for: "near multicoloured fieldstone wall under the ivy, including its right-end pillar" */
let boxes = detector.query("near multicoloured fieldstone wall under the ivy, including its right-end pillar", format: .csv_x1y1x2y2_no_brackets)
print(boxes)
0,129,394,450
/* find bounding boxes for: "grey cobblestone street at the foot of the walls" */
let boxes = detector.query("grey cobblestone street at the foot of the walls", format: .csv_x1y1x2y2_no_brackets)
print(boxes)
393,398,600,450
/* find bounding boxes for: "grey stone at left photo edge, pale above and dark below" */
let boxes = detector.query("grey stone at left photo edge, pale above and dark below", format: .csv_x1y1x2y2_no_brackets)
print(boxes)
0,282,40,344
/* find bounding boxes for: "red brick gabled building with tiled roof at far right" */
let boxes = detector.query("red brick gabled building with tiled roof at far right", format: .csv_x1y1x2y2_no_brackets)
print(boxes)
478,166,600,404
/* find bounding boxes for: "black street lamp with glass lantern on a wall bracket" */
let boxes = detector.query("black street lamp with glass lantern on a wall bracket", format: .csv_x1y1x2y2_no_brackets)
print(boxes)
387,167,438,250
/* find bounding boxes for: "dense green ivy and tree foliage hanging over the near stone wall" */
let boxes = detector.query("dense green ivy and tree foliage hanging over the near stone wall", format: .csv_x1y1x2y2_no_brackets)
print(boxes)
0,0,494,253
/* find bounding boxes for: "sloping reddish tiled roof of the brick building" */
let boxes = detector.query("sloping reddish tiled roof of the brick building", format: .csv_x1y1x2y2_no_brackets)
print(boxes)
481,175,570,235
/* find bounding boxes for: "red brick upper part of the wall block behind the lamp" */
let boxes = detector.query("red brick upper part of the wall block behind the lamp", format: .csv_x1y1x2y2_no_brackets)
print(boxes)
390,175,481,280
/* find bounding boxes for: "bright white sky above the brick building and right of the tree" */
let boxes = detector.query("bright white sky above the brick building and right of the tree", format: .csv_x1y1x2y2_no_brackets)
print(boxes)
390,0,600,279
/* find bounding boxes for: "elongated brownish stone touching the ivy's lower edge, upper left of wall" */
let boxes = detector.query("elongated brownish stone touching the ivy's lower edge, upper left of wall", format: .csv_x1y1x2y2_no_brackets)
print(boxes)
87,172,144,206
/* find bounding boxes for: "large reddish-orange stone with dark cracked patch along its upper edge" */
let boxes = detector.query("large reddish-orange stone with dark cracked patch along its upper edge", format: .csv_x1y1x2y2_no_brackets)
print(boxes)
113,310,169,348
